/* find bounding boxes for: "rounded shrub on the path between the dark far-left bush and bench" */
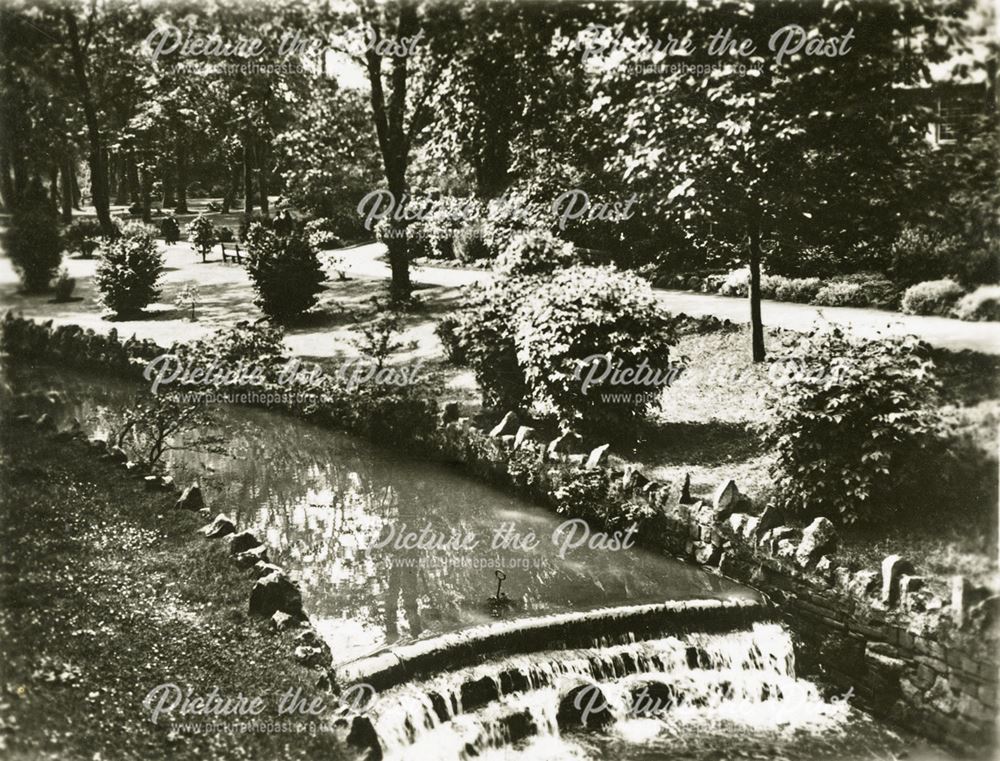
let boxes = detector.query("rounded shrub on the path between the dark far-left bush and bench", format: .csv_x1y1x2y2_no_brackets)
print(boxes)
95,224,163,316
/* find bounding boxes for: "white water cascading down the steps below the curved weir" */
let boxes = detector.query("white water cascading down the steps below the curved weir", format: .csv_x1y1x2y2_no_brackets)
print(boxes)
356,623,846,761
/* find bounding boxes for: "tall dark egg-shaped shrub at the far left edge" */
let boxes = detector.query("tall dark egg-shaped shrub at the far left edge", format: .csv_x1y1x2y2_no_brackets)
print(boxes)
3,198,62,293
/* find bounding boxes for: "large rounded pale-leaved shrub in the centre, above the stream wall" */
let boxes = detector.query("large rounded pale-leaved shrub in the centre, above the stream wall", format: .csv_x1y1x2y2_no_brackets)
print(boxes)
514,266,673,429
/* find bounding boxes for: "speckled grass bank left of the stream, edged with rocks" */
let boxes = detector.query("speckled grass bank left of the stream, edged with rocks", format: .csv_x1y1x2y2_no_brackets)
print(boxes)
0,420,347,760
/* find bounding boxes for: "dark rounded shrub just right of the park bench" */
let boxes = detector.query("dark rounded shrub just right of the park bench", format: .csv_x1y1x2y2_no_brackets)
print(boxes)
247,226,326,322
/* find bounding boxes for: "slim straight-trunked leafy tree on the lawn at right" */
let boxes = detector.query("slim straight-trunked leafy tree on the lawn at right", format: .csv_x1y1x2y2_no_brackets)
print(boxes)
595,2,948,362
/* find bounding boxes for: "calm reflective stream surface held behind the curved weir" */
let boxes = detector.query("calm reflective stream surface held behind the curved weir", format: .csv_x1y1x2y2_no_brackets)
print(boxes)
1,368,751,659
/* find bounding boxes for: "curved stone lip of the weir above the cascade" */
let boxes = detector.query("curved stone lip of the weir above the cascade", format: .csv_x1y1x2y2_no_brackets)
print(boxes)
331,600,773,691
